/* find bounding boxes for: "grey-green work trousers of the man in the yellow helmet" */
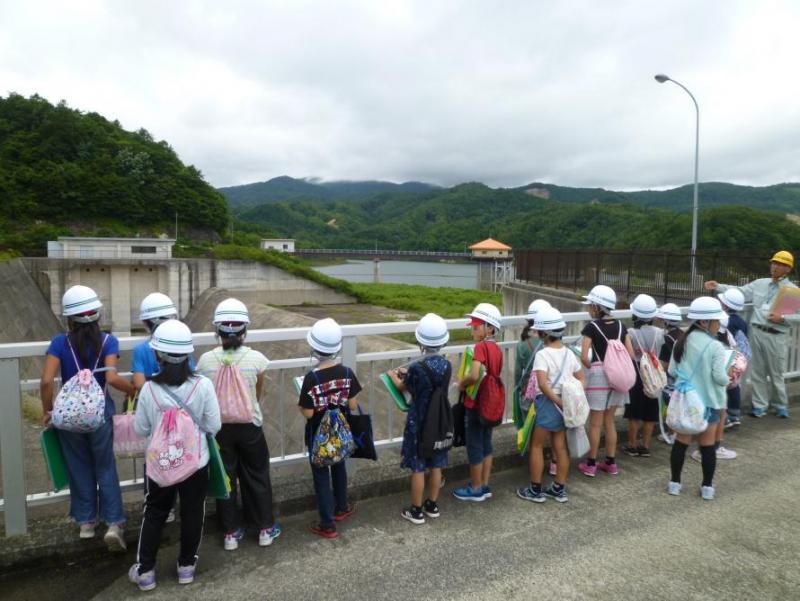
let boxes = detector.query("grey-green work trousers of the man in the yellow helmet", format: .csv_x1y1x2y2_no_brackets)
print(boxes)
748,327,789,411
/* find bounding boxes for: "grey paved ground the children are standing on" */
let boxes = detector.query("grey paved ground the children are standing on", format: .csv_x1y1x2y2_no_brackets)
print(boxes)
0,417,800,601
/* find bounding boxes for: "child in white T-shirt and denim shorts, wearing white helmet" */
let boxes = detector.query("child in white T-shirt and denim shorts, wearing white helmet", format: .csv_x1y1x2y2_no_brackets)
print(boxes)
517,307,585,503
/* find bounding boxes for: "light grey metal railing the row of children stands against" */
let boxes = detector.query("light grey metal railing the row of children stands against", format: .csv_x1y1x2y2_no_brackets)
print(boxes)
0,311,800,536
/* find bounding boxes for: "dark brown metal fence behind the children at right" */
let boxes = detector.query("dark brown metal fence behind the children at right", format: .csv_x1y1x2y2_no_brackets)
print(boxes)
514,249,768,303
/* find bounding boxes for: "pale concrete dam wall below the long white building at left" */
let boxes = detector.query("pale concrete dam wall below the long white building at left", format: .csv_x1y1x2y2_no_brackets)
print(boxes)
21,258,353,335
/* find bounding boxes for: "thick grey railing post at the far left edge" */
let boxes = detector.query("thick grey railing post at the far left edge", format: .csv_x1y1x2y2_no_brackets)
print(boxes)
0,358,28,536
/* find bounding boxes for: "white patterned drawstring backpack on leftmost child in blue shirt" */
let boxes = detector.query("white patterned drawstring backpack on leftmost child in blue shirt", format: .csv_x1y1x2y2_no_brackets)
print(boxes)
51,335,109,434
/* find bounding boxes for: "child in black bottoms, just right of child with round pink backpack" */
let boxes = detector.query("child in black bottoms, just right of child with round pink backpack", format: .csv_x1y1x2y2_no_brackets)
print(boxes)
622,294,664,457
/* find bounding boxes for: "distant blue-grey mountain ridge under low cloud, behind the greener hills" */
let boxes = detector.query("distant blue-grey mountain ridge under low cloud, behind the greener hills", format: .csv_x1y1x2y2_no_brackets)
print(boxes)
219,175,436,207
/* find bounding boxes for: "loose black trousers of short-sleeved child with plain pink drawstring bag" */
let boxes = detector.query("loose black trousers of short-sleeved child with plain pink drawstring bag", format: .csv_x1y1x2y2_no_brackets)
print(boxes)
217,424,275,533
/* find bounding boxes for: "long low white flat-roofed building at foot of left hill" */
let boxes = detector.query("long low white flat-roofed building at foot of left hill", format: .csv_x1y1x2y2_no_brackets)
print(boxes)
47,237,175,259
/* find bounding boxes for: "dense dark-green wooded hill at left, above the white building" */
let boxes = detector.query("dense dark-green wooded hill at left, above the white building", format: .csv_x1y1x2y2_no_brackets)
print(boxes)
0,94,229,250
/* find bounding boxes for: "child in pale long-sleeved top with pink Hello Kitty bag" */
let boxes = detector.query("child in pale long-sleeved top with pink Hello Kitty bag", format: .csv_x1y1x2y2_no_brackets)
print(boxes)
128,319,221,591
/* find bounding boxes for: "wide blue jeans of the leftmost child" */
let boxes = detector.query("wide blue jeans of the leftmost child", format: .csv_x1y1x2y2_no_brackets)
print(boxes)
56,401,125,524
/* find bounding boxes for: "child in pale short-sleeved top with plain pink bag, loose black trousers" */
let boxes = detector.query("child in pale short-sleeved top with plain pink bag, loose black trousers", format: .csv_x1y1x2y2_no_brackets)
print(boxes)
197,298,281,551
